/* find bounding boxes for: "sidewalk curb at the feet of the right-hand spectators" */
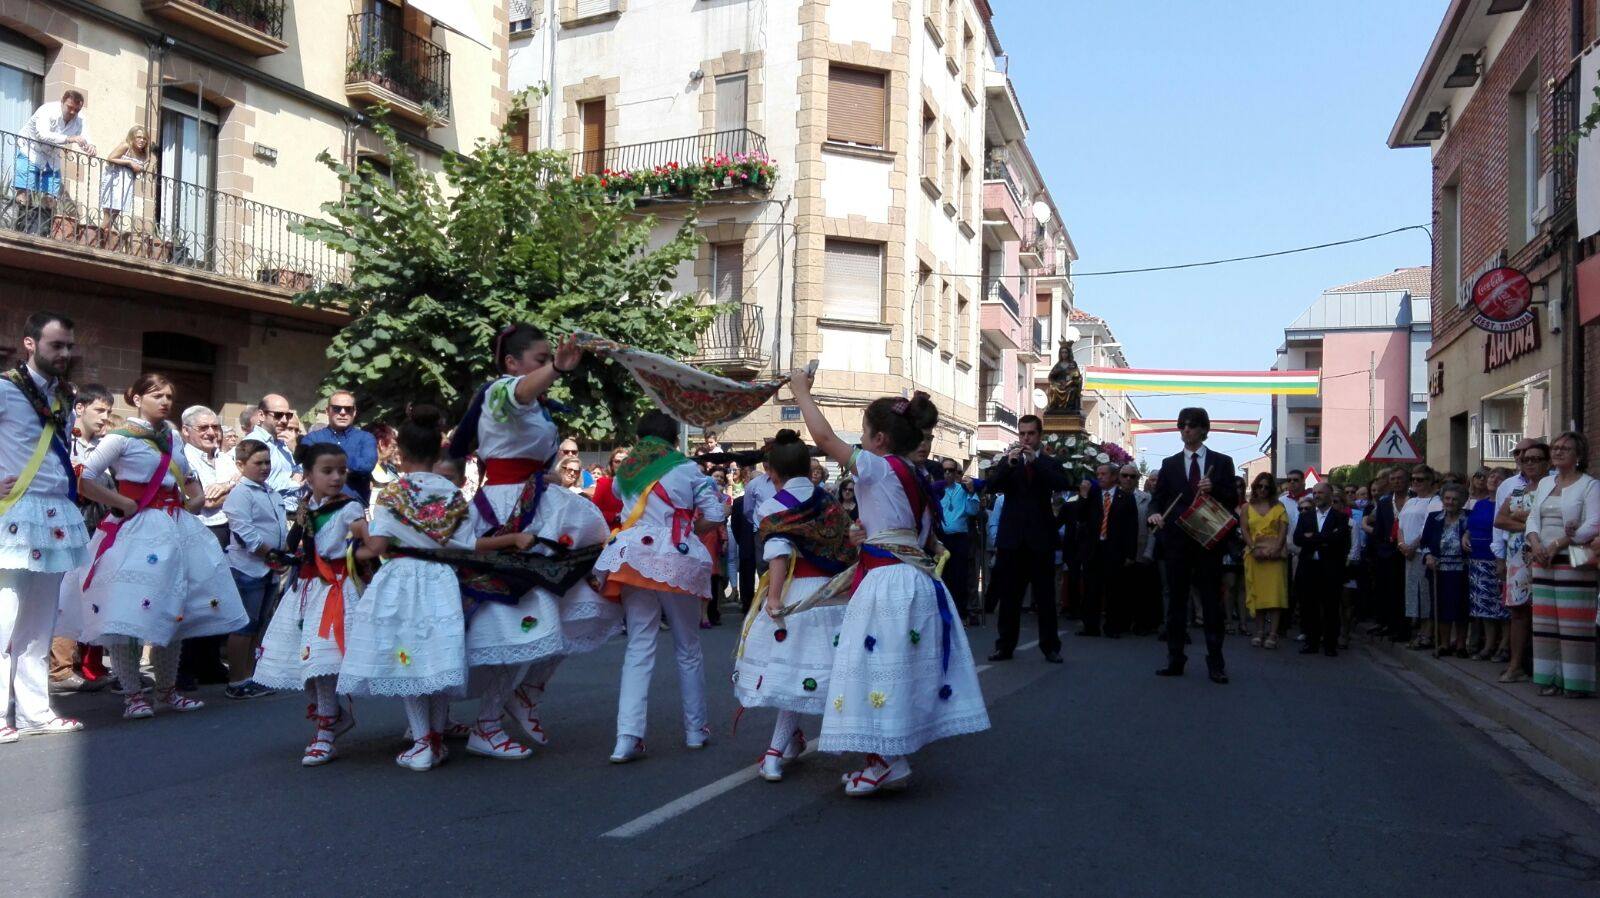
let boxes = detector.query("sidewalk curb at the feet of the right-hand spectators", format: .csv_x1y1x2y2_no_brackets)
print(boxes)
1368,642,1600,788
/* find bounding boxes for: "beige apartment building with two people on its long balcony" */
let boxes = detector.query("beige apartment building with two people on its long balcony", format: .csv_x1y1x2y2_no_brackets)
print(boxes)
0,0,509,413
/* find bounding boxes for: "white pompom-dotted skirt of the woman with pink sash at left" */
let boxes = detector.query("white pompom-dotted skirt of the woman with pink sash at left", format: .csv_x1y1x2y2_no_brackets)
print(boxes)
56,509,250,645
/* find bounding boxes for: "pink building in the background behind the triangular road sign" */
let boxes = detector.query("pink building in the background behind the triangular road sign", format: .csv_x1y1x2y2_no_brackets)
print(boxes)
1272,266,1432,477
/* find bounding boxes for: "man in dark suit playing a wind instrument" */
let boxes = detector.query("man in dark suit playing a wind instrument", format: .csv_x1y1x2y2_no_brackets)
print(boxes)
987,415,1072,664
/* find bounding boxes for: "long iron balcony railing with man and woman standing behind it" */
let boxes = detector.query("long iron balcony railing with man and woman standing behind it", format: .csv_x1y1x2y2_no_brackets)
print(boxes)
0,131,347,291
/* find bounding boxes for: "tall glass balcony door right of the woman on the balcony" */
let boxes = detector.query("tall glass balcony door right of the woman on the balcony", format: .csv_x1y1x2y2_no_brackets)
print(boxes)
158,88,221,267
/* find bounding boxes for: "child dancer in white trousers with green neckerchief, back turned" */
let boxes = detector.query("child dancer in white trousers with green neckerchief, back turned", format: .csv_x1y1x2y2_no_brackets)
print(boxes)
595,411,725,764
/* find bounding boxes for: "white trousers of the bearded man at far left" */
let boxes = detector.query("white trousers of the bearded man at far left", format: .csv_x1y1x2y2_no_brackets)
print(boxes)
0,570,66,730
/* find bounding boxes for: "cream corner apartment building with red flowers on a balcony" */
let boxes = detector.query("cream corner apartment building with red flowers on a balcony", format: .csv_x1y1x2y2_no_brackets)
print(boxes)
510,0,1075,458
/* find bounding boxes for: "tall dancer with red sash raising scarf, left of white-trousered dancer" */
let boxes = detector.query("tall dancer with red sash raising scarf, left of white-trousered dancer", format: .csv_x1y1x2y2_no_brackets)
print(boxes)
450,325,622,760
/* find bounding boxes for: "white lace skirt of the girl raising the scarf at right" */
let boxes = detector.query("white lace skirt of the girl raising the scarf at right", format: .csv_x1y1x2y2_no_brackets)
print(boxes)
819,565,989,756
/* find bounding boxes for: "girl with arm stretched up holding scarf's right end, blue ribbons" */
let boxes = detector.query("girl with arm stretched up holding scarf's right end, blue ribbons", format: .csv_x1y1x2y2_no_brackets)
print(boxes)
789,370,989,796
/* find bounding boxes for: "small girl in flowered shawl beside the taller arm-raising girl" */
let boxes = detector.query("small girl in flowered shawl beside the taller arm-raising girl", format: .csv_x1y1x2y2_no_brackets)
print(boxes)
733,431,858,783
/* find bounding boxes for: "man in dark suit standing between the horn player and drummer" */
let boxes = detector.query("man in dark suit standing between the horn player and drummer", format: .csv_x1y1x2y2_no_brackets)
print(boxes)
1072,464,1142,639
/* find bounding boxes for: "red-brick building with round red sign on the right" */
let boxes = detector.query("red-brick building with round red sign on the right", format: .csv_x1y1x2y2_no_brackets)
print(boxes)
1389,0,1595,471
